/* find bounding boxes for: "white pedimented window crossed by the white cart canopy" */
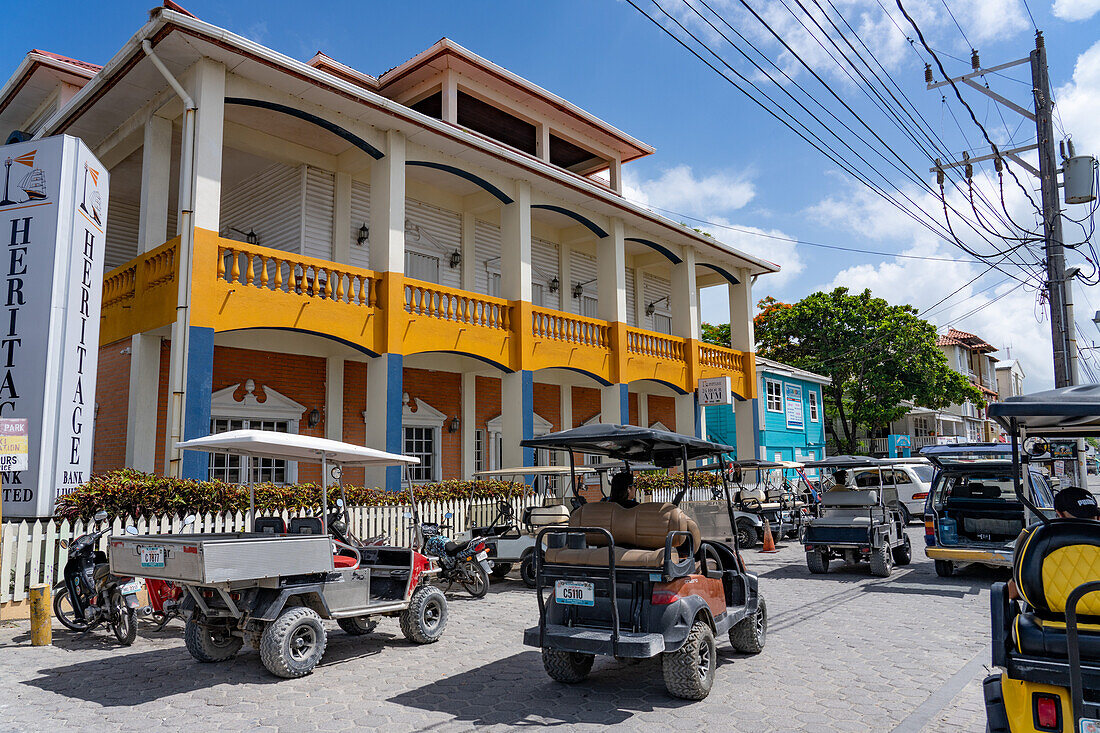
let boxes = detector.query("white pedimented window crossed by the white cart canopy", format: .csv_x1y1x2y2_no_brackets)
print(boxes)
207,380,306,484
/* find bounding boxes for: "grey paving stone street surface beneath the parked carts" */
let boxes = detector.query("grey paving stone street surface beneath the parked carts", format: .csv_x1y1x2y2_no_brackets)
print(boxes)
0,525,1005,733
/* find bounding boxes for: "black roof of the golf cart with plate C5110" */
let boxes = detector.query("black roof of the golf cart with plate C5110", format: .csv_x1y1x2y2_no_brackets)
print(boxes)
520,424,736,467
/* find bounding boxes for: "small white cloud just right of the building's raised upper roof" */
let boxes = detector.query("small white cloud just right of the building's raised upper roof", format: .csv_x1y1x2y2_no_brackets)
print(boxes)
623,165,756,218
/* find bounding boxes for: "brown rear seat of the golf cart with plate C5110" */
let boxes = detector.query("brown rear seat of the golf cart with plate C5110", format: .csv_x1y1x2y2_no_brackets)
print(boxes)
546,502,702,569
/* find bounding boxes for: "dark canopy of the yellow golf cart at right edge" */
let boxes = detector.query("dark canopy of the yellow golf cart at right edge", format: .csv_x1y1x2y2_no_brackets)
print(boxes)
989,384,1100,437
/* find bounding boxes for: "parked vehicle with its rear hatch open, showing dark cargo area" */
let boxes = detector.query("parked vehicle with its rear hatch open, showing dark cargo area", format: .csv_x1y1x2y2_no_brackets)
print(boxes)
921,442,1054,578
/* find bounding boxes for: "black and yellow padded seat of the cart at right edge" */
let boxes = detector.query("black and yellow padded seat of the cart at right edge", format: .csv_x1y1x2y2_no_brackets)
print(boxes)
1012,519,1100,661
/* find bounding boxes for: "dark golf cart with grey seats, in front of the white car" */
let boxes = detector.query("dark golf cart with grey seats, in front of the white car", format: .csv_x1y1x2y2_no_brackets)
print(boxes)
800,456,913,578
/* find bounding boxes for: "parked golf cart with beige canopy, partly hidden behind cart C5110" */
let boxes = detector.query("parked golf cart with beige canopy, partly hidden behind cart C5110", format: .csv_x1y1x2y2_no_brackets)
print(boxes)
455,466,592,588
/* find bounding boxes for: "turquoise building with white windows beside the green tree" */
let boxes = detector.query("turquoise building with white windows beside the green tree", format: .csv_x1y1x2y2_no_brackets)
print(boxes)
704,355,832,461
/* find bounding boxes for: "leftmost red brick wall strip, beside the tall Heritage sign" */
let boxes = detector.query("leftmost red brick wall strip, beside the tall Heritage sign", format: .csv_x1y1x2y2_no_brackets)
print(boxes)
91,338,130,472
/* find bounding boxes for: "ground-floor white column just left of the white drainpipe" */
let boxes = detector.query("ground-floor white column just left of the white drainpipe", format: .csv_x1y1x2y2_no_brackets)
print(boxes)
127,333,161,472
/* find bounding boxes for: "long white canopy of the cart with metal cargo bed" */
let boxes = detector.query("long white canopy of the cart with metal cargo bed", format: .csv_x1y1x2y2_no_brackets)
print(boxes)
176,430,420,467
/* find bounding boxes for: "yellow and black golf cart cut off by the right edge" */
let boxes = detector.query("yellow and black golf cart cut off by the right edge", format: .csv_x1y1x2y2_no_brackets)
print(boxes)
983,384,1100,733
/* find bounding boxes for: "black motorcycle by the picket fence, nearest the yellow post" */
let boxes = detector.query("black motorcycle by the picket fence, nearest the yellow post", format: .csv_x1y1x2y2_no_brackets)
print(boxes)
53,512,143,646
